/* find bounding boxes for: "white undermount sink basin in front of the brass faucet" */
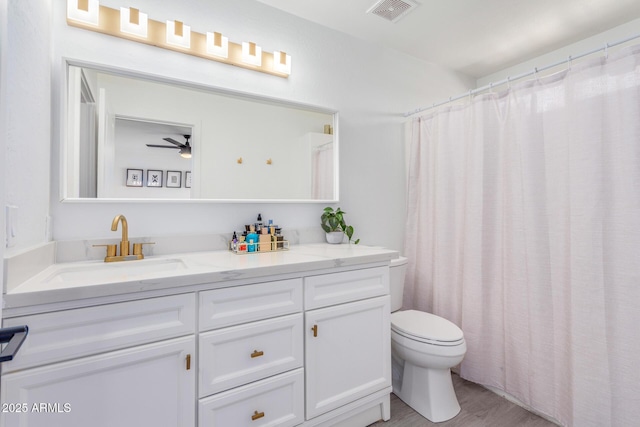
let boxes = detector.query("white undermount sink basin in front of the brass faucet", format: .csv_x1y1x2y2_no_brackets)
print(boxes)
44,258,187,283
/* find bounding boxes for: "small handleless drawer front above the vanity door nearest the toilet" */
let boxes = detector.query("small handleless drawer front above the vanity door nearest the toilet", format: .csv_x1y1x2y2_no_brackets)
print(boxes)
304,267,389,310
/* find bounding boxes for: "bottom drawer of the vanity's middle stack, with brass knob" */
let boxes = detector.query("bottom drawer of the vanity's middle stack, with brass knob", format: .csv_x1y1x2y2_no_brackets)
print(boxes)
198,368,304,427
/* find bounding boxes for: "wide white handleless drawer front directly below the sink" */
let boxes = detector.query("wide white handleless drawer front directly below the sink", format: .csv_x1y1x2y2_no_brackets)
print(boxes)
2,294,195,373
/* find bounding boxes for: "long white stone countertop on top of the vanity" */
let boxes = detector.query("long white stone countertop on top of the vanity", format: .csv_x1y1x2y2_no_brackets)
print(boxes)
4,243,398,317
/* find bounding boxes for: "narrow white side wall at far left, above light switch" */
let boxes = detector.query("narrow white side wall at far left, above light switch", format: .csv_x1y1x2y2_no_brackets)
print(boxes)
0,0,51,254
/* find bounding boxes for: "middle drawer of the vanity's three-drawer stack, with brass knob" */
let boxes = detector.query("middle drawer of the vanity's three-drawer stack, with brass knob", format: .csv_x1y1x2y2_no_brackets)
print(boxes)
198,313,303,397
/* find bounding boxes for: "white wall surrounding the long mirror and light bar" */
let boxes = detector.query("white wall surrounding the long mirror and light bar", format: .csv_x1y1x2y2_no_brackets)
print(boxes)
42,0,474,249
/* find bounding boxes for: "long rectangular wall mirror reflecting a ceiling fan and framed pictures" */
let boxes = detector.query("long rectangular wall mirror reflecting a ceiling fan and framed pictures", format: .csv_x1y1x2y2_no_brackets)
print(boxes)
62,65,338,201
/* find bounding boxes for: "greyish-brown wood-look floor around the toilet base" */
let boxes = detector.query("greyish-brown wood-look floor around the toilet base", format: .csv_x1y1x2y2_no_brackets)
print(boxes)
370,374,557,427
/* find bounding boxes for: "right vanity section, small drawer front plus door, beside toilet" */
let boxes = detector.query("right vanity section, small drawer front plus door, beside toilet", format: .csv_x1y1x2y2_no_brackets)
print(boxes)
305,267,391,425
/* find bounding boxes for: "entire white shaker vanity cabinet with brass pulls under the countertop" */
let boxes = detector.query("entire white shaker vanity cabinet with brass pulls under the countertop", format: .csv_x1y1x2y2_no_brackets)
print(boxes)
0,245,391,427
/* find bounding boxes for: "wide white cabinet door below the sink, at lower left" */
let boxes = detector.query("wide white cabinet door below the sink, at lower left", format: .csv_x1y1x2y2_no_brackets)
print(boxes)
0,336,195,427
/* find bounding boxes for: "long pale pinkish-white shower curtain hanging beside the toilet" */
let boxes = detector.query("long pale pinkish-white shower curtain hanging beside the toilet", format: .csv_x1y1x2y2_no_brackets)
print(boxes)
404,47,640,427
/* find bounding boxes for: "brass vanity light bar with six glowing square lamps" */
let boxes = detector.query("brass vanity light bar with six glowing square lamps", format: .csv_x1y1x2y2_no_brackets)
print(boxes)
67,0,291,78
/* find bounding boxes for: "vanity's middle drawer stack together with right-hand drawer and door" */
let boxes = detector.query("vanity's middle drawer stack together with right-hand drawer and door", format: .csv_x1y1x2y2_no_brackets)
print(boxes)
198,267,391,427
